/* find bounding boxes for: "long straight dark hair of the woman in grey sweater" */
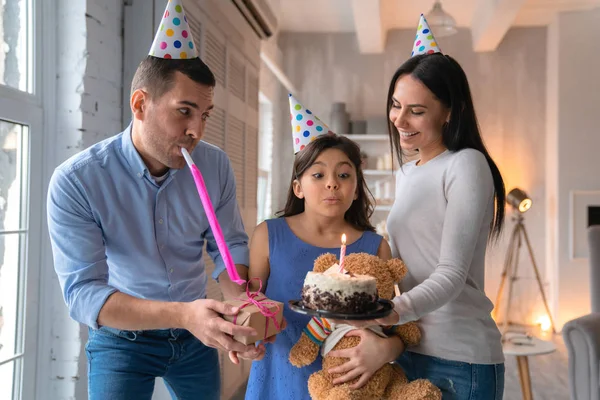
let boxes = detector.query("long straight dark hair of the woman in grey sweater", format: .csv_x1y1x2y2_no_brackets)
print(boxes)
386,53,506,239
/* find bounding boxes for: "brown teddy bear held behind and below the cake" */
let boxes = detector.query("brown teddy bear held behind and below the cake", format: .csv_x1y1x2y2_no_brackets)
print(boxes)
289,253,442,400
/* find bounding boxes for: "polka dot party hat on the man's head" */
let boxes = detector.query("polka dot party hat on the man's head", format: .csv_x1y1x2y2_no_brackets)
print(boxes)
148,0,198,59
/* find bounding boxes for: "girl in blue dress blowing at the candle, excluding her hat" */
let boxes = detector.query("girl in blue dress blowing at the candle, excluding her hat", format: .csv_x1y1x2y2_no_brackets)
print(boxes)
246,135,402,400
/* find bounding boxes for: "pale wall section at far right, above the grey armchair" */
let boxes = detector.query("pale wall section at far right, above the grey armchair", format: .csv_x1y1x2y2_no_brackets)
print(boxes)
546,9,600,325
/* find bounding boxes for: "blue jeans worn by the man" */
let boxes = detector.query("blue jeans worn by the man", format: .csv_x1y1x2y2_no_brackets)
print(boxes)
85,327,220,400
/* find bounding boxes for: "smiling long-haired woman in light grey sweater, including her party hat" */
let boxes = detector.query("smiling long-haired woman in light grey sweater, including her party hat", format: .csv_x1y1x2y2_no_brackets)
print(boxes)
346,14,505,400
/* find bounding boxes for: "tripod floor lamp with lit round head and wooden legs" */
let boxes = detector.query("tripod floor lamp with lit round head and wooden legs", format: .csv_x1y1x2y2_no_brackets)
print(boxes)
493,188,556,336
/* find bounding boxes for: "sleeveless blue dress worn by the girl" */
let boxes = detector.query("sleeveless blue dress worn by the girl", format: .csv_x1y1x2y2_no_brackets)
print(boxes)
246,218,382,400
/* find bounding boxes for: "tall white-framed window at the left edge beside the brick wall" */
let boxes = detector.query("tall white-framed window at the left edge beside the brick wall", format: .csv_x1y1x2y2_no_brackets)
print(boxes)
0,0,43,400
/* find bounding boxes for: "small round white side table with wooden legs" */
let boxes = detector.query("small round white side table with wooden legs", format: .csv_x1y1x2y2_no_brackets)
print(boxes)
502,332,556,400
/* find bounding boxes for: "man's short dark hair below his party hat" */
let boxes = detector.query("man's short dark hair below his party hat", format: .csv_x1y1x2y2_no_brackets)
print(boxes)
131,56,216,99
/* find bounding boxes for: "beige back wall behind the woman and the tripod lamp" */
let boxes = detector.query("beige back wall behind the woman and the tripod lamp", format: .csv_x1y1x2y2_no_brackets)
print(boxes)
273,28,546,322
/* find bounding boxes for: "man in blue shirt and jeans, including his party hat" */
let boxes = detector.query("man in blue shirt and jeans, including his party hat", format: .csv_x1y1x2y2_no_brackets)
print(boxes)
48,0,264,400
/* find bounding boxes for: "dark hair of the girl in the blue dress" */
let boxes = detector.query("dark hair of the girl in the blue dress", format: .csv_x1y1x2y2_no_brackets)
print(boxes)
277,134,375,231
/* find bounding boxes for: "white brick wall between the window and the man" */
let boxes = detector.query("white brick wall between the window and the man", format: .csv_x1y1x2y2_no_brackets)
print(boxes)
49,0,123,400
